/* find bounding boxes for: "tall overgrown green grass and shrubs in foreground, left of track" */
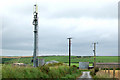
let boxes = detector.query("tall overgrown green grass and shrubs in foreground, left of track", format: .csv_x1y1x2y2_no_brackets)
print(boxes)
2,64,81,78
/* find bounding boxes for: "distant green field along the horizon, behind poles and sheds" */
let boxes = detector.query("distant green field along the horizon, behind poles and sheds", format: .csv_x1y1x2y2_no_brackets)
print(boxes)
2,56,118,66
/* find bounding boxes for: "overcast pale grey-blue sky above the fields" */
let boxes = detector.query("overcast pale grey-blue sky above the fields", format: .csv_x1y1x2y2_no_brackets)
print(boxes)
0,0,119,56
